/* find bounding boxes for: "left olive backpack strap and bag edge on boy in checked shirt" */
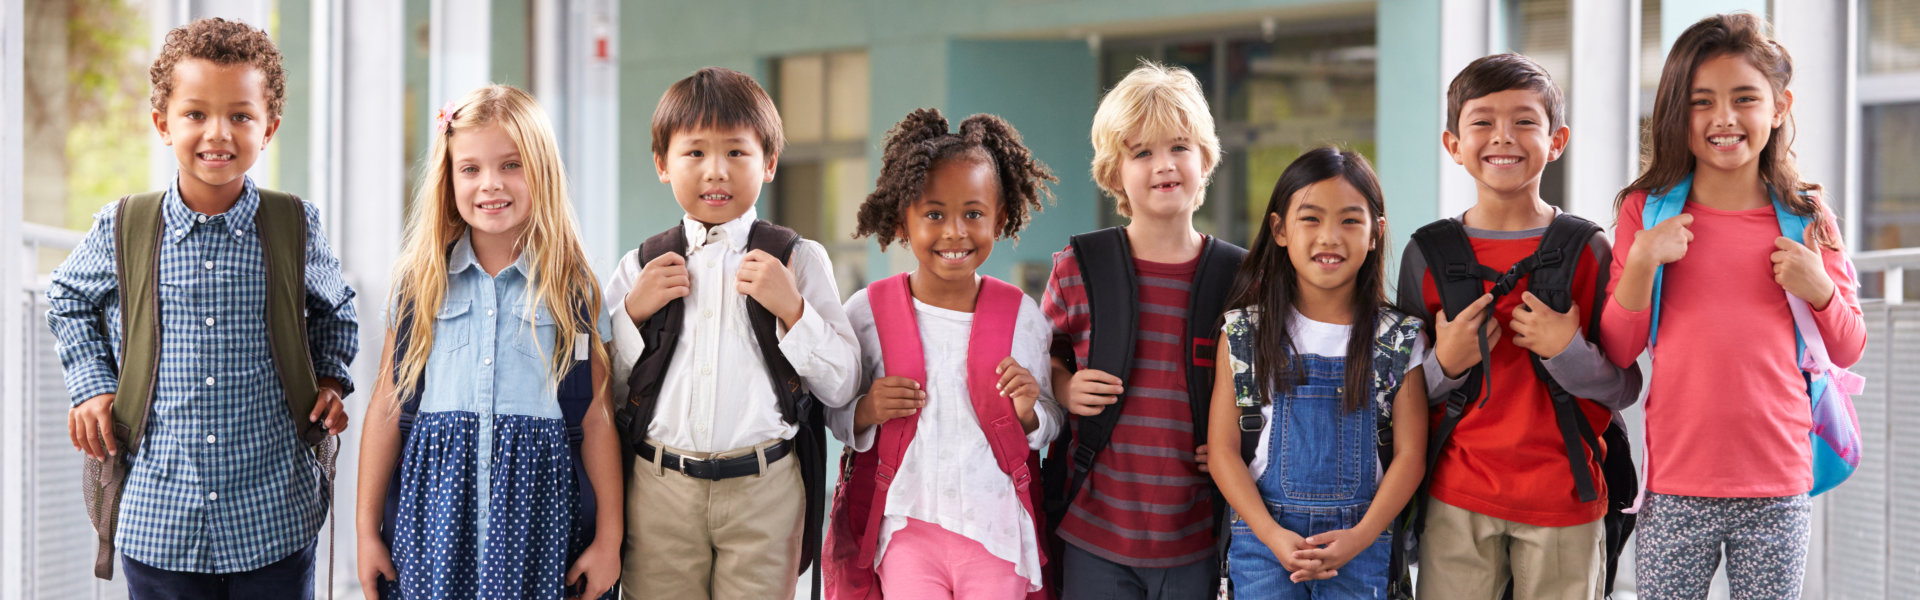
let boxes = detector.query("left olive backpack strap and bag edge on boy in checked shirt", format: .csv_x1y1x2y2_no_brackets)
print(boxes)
81,192,167,579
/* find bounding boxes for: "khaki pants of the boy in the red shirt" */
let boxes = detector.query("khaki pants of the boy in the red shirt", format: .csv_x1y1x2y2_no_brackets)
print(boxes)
1417,498,1607,600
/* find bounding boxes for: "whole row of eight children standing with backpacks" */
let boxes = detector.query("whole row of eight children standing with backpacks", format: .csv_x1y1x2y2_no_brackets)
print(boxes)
48,13,1864,598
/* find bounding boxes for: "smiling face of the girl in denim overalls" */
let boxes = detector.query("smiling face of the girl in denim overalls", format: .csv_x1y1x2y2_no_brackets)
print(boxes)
1267,177,1386,292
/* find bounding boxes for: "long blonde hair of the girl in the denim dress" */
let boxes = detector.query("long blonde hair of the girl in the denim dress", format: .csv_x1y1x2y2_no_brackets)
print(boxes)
382,85,607,408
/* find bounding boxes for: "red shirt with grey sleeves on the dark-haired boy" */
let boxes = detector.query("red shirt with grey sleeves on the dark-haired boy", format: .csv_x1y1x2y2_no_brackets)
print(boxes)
1398,219,1640,527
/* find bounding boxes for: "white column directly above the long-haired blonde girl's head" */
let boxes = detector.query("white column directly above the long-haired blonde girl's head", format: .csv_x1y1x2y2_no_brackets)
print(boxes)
430,0,493,115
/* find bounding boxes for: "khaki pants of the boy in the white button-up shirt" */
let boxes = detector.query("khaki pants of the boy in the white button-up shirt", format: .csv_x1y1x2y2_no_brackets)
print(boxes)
620,440,806,600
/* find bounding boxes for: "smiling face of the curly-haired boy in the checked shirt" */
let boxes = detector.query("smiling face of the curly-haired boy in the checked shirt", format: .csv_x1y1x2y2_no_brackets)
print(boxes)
152,58,280,202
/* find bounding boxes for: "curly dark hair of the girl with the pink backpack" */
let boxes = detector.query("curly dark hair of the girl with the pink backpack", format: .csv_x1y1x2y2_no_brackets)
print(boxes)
852,108,1060,248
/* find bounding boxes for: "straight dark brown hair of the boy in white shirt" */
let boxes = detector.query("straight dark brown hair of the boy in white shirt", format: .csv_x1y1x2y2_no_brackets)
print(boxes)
653,67,787,163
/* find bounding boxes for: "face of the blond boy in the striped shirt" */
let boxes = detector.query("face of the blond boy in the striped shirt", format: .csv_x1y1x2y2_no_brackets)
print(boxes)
1119,133,1206,219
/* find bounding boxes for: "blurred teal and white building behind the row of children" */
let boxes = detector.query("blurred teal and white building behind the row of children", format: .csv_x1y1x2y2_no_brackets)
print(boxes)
0,0,1920,598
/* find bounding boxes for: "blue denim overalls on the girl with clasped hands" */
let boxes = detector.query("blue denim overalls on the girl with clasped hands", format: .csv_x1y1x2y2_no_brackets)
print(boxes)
1227,354,1392,600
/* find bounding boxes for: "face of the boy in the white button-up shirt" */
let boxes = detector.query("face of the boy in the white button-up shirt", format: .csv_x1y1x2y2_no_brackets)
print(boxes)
653,127,778,225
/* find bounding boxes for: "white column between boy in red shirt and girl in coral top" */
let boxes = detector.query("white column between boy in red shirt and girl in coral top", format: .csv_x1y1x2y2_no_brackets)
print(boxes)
1563,0,1640,223
